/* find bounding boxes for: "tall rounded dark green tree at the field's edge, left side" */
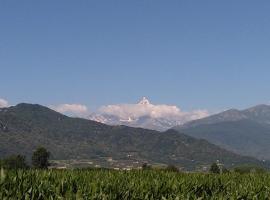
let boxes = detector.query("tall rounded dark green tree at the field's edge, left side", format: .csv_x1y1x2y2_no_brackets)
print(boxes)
32,147,50,169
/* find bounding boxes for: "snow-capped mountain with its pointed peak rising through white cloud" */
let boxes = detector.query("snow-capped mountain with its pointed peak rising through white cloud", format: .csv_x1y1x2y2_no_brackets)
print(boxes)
89,97,208,131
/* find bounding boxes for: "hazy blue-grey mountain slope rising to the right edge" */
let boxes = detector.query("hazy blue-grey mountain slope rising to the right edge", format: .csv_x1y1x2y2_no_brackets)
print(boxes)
174,105,270,160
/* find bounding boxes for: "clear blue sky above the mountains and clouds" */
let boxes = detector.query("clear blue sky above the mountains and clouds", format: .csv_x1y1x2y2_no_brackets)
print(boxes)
0,0,270,111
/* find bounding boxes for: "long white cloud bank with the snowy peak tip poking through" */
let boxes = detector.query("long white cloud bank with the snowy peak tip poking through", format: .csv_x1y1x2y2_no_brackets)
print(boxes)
99,98,209,122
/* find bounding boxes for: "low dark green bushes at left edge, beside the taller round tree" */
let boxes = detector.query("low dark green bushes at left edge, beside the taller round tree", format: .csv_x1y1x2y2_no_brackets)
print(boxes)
0,155,28,170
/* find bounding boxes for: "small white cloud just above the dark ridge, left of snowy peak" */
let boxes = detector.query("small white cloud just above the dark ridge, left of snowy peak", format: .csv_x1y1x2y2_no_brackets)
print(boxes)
50,104,88,116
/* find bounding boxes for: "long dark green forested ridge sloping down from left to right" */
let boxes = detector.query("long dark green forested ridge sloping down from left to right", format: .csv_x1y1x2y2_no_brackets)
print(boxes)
0,104,263,169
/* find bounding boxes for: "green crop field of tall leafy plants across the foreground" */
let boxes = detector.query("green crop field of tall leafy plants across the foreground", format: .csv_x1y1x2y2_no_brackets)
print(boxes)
0,170,270,200
